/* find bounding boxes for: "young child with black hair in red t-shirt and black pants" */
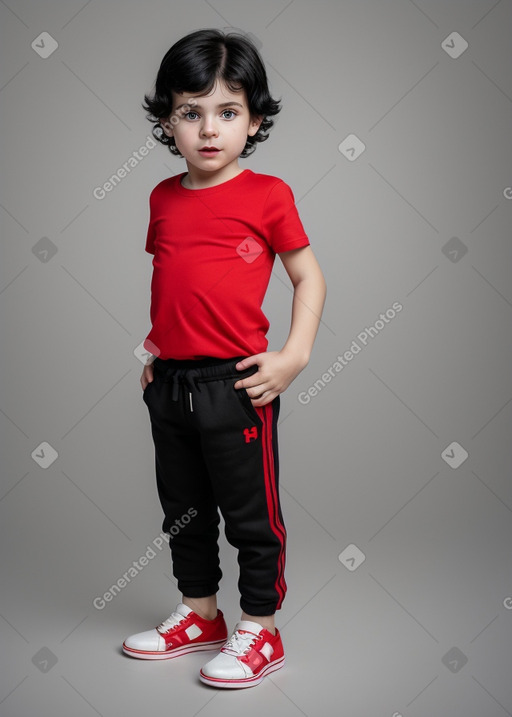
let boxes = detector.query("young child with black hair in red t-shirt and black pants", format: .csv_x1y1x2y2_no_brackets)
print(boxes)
123,30,325,688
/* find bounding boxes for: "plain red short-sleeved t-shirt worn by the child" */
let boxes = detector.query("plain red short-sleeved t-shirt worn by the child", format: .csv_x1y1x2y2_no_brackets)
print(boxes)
144,169,309,359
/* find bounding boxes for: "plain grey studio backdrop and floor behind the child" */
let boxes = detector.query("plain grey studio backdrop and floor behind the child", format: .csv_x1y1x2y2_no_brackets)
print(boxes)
0,0,512,717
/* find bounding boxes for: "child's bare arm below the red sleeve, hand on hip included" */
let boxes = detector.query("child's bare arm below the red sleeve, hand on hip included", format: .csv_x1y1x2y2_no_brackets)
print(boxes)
235,246,326,406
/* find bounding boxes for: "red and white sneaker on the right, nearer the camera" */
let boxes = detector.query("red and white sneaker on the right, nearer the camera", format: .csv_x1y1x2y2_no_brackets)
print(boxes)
199,620,284,688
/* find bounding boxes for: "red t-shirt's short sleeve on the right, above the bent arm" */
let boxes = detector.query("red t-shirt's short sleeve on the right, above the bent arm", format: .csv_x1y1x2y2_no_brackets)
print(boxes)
262,180,309,254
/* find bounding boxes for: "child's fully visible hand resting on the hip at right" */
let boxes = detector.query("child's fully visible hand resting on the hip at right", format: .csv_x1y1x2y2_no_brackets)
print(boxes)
235,351,306,406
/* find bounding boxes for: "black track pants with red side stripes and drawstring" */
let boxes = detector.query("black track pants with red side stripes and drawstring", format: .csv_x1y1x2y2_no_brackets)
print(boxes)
143,357,286,616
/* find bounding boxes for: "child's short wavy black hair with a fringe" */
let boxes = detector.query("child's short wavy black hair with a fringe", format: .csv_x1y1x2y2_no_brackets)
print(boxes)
142,29,281,157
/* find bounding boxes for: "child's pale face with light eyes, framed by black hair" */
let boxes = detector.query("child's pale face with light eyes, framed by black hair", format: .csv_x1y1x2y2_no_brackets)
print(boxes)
160,82,263,172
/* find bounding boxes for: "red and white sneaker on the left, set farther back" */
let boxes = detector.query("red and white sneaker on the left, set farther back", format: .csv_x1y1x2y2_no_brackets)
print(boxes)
123,603,228,660
